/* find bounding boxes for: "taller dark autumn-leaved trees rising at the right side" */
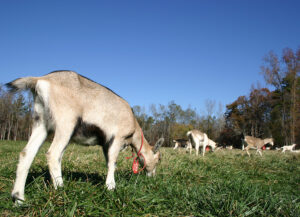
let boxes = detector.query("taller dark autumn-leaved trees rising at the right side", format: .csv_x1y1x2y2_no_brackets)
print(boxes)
221,48,300,149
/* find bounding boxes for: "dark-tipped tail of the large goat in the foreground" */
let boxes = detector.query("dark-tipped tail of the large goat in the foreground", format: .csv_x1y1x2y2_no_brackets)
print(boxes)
5,77,38,92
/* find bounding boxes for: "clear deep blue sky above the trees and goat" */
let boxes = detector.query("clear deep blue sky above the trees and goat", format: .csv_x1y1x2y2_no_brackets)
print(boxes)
0,0,300,112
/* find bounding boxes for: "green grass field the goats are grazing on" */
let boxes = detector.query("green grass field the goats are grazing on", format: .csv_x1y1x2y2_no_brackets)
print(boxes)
0,141,300,216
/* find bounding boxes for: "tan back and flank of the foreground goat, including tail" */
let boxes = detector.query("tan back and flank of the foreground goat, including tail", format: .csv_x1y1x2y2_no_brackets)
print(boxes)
8,71,137,140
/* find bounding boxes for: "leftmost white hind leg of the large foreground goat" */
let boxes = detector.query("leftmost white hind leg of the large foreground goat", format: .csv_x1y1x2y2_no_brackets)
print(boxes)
11,121,47,203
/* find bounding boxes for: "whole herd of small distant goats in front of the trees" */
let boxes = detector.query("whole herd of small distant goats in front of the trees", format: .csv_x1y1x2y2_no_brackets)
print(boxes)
173,129,299,157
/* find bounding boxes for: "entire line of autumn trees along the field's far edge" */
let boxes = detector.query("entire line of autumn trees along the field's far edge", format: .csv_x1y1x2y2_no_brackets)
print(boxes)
0,48,300,147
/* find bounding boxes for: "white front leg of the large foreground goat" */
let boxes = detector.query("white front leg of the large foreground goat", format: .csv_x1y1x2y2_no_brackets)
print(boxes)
103,138,122,190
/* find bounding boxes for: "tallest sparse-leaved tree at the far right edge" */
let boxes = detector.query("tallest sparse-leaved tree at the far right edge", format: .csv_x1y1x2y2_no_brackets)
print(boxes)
261,48,300,145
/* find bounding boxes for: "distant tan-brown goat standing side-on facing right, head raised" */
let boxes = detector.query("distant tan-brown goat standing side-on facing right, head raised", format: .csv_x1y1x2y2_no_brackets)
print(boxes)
243,136,274,157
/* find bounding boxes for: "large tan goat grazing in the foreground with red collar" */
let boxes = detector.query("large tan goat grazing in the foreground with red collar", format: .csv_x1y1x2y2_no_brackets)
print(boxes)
7,71,163,203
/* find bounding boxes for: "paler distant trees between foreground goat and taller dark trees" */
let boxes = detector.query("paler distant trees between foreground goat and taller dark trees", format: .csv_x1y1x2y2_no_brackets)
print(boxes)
133,100,225,147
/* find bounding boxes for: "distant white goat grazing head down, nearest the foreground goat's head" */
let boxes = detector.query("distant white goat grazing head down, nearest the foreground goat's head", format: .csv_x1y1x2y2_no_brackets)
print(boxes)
187,130,216,156
